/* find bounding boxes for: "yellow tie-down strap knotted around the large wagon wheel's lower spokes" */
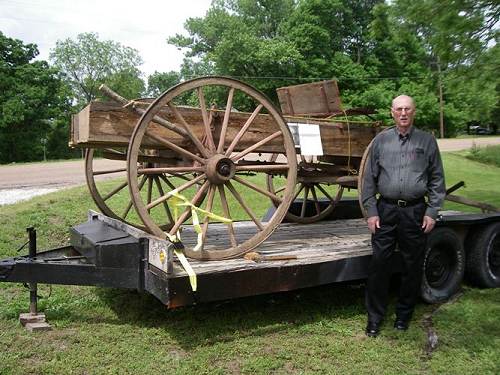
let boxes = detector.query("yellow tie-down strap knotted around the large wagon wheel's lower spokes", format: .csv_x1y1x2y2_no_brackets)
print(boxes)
165,189,232,292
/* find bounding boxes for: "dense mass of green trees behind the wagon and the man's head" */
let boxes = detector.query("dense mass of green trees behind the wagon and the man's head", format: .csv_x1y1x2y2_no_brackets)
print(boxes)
169,0,500,136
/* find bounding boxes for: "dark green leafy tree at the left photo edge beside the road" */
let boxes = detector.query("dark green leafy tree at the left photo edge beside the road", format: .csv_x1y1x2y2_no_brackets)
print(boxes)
0,32,70,163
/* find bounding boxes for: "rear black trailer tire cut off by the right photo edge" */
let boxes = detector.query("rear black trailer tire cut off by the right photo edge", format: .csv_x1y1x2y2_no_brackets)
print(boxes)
467,223,500,288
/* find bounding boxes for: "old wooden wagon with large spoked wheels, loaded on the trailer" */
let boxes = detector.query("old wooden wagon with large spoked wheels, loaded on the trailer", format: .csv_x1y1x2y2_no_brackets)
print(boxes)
70,77,380,259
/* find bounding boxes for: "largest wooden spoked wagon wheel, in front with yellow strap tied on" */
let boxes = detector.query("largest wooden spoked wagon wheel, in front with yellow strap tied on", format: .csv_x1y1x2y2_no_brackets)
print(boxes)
127,77,297,259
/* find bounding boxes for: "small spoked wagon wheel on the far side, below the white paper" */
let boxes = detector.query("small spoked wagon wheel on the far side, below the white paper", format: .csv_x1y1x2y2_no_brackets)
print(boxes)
266,154,344,224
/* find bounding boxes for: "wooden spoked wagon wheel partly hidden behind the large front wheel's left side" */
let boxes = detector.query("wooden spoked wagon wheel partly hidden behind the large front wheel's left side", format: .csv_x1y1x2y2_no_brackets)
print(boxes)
85,147,182,229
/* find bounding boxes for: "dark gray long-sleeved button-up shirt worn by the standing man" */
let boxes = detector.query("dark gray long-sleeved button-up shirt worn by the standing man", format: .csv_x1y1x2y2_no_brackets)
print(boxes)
361,126,446,219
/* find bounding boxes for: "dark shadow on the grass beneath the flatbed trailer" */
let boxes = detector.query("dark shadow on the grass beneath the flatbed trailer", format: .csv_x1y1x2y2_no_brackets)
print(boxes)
96,284,365,349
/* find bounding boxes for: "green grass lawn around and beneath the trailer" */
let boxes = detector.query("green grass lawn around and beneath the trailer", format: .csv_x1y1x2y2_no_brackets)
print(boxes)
0,154,500,375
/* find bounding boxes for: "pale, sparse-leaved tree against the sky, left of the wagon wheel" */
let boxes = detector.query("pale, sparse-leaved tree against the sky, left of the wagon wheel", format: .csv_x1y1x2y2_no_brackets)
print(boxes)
50,33,144,106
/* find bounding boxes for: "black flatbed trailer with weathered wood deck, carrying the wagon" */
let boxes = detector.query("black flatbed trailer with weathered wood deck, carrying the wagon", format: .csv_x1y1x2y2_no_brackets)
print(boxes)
0,200,500,308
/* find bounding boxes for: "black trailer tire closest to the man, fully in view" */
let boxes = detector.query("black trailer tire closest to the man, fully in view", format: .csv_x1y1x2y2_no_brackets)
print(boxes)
422,228,465,303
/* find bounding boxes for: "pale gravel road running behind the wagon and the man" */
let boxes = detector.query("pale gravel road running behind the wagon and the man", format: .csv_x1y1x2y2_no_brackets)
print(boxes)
0,137,500,205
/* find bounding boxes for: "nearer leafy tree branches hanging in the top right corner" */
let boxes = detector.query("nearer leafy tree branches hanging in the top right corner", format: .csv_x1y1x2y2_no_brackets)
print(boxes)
394,0,500,134
